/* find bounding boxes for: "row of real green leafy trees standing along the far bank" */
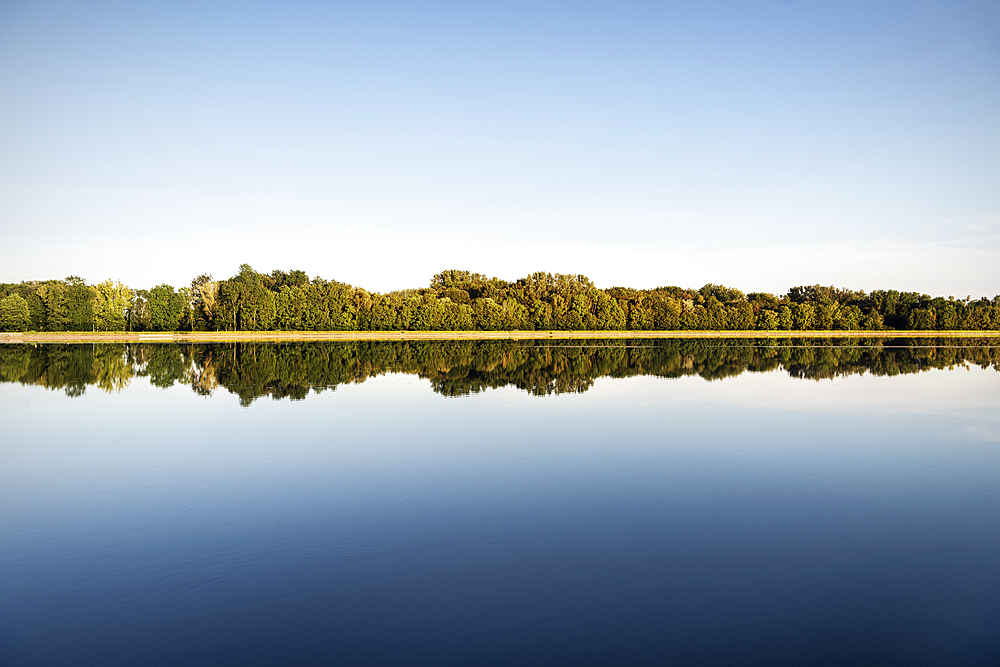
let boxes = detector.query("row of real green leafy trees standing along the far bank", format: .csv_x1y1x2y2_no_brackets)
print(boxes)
0,264,1000,331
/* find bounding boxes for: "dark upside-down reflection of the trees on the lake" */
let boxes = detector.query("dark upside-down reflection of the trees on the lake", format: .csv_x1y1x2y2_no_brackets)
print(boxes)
0,338,1000,405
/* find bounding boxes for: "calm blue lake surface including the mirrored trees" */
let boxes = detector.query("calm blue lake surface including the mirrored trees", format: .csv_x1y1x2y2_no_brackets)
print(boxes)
0,340,1000,666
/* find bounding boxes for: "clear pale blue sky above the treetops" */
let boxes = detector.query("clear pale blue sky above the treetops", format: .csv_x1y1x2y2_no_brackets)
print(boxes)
0,0,1000,297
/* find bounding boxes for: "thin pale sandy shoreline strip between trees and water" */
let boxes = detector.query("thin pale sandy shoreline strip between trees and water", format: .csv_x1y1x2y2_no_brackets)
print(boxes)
0,331,1000,344
